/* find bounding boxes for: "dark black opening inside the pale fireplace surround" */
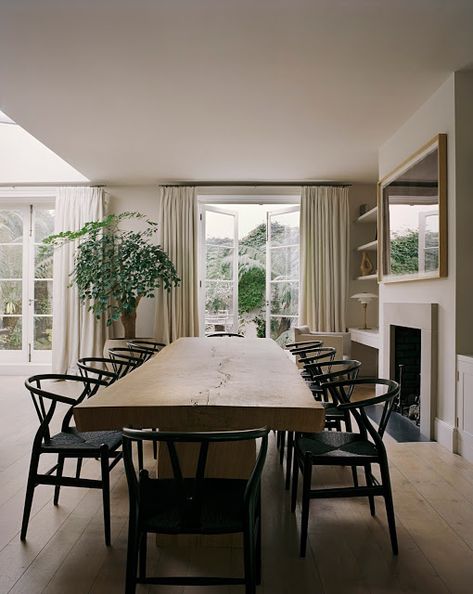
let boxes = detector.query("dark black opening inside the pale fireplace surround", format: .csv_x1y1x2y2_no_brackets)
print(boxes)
391,326,421,425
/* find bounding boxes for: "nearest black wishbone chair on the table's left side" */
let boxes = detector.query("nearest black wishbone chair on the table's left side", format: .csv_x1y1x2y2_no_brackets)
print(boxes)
20,373,122,546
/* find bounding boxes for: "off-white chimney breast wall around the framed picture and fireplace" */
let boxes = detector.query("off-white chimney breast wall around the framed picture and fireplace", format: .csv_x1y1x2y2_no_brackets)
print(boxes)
379,75,454,448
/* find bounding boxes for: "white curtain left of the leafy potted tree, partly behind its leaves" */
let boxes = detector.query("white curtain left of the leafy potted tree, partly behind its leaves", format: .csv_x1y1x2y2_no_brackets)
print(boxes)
52,187,105,373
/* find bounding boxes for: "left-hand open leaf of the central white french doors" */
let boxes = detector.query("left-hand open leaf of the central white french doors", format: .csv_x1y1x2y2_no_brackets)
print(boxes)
200,205,238,334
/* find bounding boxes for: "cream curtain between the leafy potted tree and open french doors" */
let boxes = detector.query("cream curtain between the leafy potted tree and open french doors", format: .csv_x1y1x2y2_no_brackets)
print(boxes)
155,186,199,343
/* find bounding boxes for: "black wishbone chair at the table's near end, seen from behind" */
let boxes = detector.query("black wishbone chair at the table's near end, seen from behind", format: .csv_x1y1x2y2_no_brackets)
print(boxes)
123,428,268,594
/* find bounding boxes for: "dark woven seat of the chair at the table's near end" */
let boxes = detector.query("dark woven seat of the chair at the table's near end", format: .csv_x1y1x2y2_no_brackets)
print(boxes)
140,479,247,534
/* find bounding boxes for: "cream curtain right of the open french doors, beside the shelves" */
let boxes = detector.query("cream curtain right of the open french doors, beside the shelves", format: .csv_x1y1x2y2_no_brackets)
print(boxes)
299,186,350,332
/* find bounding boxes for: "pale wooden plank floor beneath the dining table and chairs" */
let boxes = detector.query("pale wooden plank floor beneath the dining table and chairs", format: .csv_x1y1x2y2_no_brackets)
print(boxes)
0,377,473,594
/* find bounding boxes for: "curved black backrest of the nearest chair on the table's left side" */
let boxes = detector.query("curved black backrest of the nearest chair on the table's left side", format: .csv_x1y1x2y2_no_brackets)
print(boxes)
25,373,107,445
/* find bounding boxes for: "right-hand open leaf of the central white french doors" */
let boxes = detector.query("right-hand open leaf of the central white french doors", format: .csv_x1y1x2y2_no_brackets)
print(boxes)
266,206,300,342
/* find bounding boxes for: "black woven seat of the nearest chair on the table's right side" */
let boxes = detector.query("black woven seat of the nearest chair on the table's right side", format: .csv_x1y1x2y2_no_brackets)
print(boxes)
296,431,378,464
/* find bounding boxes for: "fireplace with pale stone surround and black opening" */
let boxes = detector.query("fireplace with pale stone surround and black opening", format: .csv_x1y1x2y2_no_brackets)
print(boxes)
380,303,438,439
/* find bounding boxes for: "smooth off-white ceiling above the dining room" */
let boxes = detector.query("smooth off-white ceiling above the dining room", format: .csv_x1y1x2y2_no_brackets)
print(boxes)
0,0,473,184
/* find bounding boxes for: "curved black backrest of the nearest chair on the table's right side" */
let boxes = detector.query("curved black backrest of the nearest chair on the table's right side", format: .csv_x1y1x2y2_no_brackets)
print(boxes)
322,378,400,445
